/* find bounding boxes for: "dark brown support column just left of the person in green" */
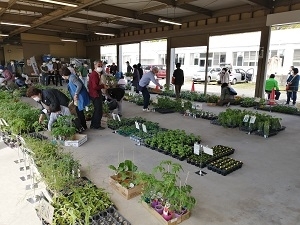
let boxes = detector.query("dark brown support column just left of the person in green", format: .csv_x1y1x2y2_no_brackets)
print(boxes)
255,27,271,98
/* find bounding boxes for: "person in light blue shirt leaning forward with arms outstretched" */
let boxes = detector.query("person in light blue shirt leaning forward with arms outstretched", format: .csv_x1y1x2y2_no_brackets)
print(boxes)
139,66,163,112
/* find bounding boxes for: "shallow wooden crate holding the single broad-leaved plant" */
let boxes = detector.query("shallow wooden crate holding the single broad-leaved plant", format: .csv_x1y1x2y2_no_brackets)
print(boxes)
109,175,142,200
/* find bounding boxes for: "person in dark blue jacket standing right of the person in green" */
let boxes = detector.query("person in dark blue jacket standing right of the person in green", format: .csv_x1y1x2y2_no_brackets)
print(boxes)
285,68,299,105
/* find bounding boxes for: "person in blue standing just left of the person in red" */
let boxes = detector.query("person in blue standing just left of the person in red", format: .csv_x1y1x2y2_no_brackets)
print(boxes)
62,67,90,129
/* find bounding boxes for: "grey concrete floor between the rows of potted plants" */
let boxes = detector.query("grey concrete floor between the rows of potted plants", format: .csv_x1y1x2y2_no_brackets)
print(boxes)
0,95,300,225
